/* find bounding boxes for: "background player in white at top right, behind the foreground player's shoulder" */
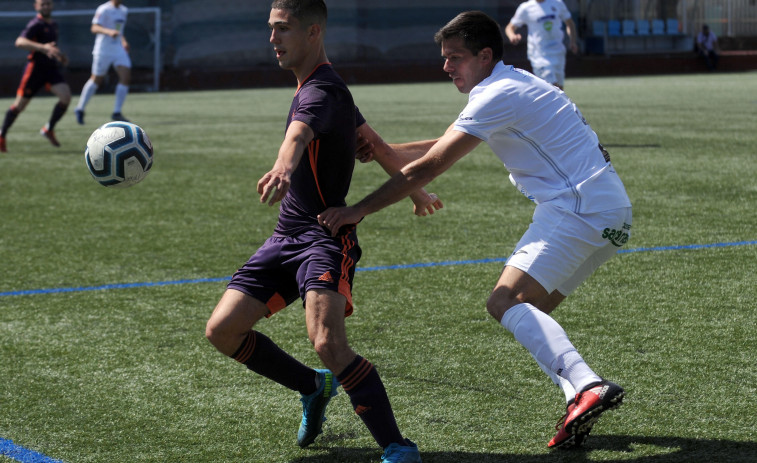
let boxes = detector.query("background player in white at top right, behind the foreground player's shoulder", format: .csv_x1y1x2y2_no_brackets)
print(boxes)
505,0,578,89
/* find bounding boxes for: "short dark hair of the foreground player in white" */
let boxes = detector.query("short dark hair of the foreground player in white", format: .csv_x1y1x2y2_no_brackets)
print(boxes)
434,11,505,62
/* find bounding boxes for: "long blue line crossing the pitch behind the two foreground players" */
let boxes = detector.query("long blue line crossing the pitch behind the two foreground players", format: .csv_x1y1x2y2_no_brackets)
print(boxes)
0,240,757,297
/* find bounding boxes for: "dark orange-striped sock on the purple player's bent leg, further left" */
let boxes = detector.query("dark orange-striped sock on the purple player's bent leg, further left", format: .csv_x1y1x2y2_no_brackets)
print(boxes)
231,331,316,395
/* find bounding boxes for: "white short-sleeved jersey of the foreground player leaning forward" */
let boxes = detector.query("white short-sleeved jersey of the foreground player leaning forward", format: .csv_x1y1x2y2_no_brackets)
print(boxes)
453,62,631,214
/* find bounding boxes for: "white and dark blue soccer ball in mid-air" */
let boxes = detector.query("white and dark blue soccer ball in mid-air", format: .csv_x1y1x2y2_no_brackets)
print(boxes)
84,122,153,187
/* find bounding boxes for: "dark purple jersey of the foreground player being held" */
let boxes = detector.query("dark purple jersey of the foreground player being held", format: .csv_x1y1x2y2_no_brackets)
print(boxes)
274,63,365,236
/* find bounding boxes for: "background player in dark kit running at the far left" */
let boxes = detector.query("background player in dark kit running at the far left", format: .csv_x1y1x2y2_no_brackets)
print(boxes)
0,0,71,153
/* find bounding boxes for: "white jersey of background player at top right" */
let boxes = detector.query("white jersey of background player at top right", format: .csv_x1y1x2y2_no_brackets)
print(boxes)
510,0,570,68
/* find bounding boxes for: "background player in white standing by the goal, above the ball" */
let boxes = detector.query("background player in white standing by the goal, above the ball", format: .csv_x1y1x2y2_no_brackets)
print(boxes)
74,0,131,124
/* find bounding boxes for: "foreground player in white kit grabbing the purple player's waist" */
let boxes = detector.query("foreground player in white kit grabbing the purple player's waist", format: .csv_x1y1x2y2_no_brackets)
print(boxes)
318,11,631,448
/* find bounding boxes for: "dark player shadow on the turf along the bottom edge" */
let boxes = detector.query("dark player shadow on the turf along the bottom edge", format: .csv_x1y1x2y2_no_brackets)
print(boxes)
291,435,757,463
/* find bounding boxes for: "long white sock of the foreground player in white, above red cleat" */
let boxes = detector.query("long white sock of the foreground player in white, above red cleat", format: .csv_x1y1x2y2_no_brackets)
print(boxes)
500,303,602,396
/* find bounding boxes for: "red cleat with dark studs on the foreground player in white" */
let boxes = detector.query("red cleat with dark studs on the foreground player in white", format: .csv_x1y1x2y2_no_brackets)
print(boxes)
547,381,625,448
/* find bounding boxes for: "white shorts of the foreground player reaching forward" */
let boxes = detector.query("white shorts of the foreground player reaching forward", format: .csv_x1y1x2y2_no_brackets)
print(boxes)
505,203,631,296
